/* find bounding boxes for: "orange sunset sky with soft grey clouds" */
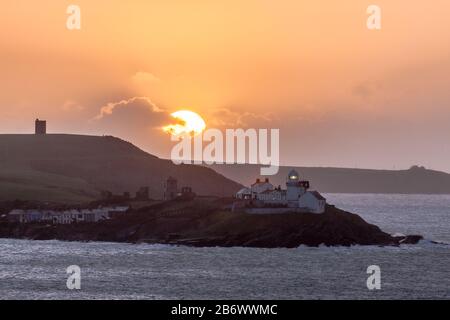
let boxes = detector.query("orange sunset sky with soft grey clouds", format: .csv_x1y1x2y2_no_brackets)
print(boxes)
0,0,450,172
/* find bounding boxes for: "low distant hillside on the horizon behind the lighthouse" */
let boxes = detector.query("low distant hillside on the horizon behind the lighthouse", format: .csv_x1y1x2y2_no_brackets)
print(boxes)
208,165,450,194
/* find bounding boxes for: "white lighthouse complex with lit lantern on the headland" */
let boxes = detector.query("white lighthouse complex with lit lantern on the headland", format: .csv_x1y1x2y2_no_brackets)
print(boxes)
236,170,326,213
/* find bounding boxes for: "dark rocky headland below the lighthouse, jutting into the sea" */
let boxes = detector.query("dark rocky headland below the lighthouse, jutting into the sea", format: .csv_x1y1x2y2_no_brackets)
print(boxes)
0,200,412,248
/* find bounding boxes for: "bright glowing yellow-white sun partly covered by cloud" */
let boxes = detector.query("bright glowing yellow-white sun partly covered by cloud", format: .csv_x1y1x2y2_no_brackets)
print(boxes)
163,110,206,135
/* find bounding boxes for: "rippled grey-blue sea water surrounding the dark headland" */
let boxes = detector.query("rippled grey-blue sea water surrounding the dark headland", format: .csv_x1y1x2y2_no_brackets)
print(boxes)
0,194,450,299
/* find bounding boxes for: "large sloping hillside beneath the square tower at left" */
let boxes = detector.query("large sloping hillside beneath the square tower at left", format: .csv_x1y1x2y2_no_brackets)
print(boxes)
0,134,241,203
